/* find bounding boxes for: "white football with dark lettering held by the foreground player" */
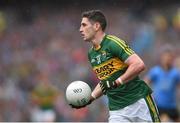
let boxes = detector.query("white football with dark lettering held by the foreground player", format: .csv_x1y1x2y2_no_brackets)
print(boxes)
66,81,91,108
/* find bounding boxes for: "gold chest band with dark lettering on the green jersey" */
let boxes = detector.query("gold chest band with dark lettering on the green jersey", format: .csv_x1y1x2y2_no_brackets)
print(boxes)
93,58,127,80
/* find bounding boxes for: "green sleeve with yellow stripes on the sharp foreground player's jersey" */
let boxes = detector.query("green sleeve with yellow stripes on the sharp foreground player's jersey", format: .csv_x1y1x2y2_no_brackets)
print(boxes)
107,38,134,61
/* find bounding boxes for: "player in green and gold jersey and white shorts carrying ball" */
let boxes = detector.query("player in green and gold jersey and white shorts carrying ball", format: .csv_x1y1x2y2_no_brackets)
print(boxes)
71,10,160,122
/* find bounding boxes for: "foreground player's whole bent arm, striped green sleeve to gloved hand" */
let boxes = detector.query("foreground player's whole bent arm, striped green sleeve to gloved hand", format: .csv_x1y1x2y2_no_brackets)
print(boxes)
100,36,145,94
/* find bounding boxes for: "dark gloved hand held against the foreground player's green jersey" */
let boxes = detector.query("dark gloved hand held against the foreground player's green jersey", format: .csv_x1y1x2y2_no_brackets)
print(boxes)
99,81,118,94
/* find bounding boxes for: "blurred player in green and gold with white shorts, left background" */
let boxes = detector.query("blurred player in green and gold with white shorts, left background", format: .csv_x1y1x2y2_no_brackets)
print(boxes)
31,71,58,122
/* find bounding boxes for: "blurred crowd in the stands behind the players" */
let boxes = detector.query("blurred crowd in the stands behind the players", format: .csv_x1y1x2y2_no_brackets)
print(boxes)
0,1,180,122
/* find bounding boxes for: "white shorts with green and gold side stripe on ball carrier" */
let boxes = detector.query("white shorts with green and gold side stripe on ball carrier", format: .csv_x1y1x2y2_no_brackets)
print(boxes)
109,95,160,123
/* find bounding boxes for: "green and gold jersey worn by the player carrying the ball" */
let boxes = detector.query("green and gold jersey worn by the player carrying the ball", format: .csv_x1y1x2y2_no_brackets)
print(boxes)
88,35,152,110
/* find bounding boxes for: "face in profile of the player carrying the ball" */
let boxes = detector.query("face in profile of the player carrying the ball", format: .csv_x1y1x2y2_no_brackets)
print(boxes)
79,17,96,41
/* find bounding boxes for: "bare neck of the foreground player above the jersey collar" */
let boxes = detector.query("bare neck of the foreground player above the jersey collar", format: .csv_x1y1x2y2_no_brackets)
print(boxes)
92,32,105,49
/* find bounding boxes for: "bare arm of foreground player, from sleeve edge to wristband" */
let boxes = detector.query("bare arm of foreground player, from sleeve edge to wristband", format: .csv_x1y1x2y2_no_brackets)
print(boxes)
116,54,145,85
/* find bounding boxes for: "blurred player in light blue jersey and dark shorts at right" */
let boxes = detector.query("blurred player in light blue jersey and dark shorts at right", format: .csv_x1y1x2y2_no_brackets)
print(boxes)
145,45,180,121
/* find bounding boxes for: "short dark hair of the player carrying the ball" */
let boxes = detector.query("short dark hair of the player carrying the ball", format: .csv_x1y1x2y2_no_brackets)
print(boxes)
82,10,107,31
